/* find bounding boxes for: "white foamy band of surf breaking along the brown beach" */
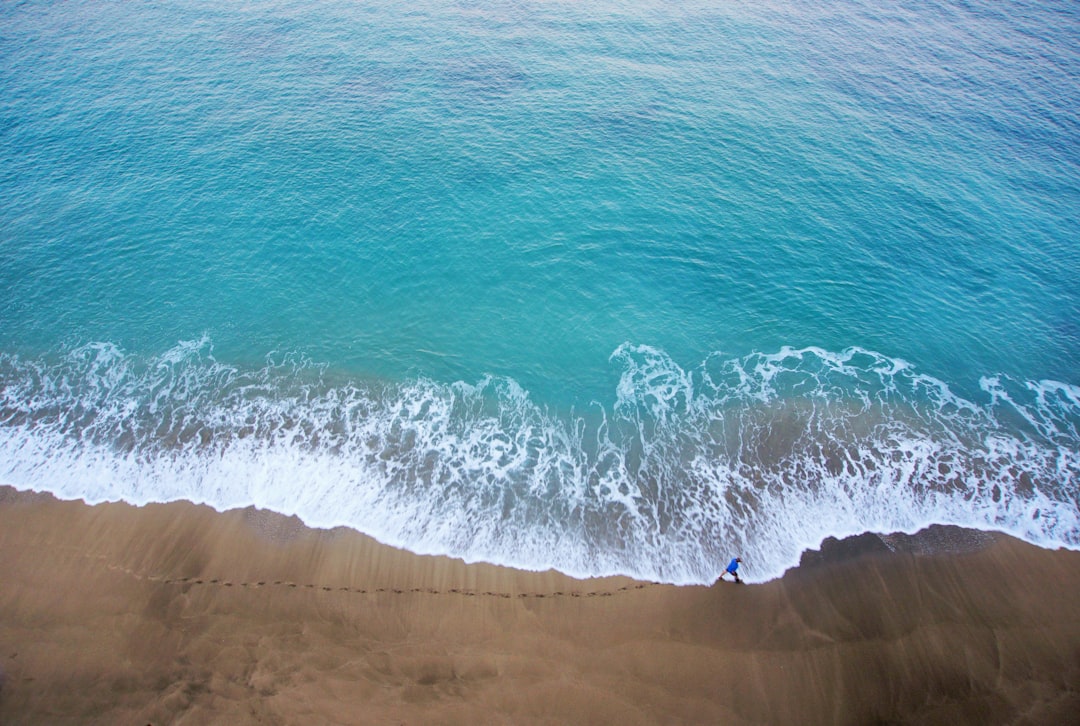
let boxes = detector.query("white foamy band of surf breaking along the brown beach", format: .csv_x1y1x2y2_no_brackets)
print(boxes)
0,338,1080,583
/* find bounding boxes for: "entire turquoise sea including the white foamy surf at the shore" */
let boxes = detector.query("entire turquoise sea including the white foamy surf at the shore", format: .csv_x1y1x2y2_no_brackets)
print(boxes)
0,1,1080,582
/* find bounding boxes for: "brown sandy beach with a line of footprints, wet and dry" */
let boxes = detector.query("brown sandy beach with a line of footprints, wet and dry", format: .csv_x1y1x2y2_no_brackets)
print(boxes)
0,487,1080,726
